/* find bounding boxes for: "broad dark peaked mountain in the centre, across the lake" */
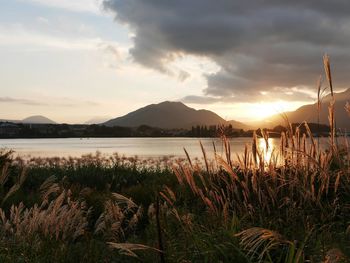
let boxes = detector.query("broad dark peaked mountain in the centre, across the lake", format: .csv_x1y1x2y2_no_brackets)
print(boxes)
104,101,246,129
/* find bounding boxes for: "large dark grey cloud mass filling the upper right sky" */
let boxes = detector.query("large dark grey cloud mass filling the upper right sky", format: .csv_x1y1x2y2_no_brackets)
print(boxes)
104,0,350,101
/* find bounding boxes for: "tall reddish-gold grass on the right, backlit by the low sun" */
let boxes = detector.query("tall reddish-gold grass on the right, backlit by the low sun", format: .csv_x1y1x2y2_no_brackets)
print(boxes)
161,55,350,262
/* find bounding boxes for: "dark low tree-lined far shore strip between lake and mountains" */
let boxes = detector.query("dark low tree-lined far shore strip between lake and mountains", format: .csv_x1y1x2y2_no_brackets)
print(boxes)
0,122,329,139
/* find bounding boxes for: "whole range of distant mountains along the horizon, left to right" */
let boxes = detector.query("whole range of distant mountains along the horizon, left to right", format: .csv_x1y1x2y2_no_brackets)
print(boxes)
0,89,350,131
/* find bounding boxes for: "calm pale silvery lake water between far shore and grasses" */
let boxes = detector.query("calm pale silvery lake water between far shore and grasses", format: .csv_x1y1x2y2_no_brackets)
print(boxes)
0,138,279,160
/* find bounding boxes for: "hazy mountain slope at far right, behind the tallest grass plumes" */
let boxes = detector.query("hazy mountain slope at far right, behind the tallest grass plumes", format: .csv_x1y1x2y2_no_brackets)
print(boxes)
265,88,350,131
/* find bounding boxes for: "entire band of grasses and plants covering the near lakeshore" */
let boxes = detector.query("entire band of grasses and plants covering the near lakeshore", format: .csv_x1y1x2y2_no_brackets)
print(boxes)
0,57,350,263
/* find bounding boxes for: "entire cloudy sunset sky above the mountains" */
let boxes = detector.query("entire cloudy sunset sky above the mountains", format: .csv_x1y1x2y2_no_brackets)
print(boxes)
0,0,350,123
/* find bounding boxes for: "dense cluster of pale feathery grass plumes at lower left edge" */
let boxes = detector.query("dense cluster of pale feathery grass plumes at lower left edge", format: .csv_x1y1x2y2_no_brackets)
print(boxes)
0,191,88,241
